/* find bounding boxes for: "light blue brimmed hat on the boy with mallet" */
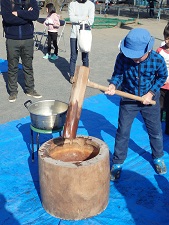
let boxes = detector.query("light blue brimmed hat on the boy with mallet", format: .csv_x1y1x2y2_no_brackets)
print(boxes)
120,28,154,59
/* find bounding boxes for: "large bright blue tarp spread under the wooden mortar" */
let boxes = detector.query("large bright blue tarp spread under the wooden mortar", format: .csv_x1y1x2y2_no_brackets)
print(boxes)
0,94,169,225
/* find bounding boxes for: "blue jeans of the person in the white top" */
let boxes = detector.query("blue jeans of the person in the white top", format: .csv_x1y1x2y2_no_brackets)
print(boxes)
70,38,89,76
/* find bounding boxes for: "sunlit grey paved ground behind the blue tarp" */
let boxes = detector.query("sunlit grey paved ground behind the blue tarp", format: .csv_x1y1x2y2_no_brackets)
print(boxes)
0,9,167,124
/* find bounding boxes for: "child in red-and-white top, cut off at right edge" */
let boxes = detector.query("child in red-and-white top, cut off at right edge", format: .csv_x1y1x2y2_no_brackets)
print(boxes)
157,23,169,135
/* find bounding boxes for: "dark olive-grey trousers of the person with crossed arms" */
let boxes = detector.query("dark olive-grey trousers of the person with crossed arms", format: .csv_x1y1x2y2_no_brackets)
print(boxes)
6,39,34,94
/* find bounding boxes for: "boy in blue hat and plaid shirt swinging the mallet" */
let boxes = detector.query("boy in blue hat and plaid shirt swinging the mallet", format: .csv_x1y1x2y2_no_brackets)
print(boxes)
105,28,168,181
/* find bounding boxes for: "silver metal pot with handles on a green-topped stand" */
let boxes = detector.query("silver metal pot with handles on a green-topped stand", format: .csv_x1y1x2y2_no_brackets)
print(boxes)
24,100,68,130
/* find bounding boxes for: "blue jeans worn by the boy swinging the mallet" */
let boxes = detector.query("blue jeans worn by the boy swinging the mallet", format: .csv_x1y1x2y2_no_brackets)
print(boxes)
113,93,164,164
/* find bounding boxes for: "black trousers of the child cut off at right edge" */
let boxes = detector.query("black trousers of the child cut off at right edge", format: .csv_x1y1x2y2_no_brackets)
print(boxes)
160,88,169,134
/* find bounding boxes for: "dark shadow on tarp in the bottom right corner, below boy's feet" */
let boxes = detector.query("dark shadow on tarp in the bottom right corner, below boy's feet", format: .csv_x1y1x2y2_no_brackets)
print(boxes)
114,170,169,225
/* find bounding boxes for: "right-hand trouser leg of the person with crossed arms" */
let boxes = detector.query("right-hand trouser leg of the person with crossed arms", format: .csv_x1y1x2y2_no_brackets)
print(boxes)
21,39,34,93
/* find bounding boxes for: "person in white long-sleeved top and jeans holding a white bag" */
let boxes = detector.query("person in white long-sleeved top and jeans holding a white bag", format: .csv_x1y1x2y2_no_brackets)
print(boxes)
68,0,95,83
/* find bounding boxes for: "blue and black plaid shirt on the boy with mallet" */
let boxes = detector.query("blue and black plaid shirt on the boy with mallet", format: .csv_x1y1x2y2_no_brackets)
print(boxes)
110,51,168,96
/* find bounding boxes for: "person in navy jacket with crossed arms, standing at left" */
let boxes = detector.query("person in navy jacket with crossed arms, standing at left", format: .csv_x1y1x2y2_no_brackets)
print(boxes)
1,0,42,102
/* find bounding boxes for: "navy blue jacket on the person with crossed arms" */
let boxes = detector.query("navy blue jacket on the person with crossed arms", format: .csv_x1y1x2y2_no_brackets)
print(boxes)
1,0,39,40
